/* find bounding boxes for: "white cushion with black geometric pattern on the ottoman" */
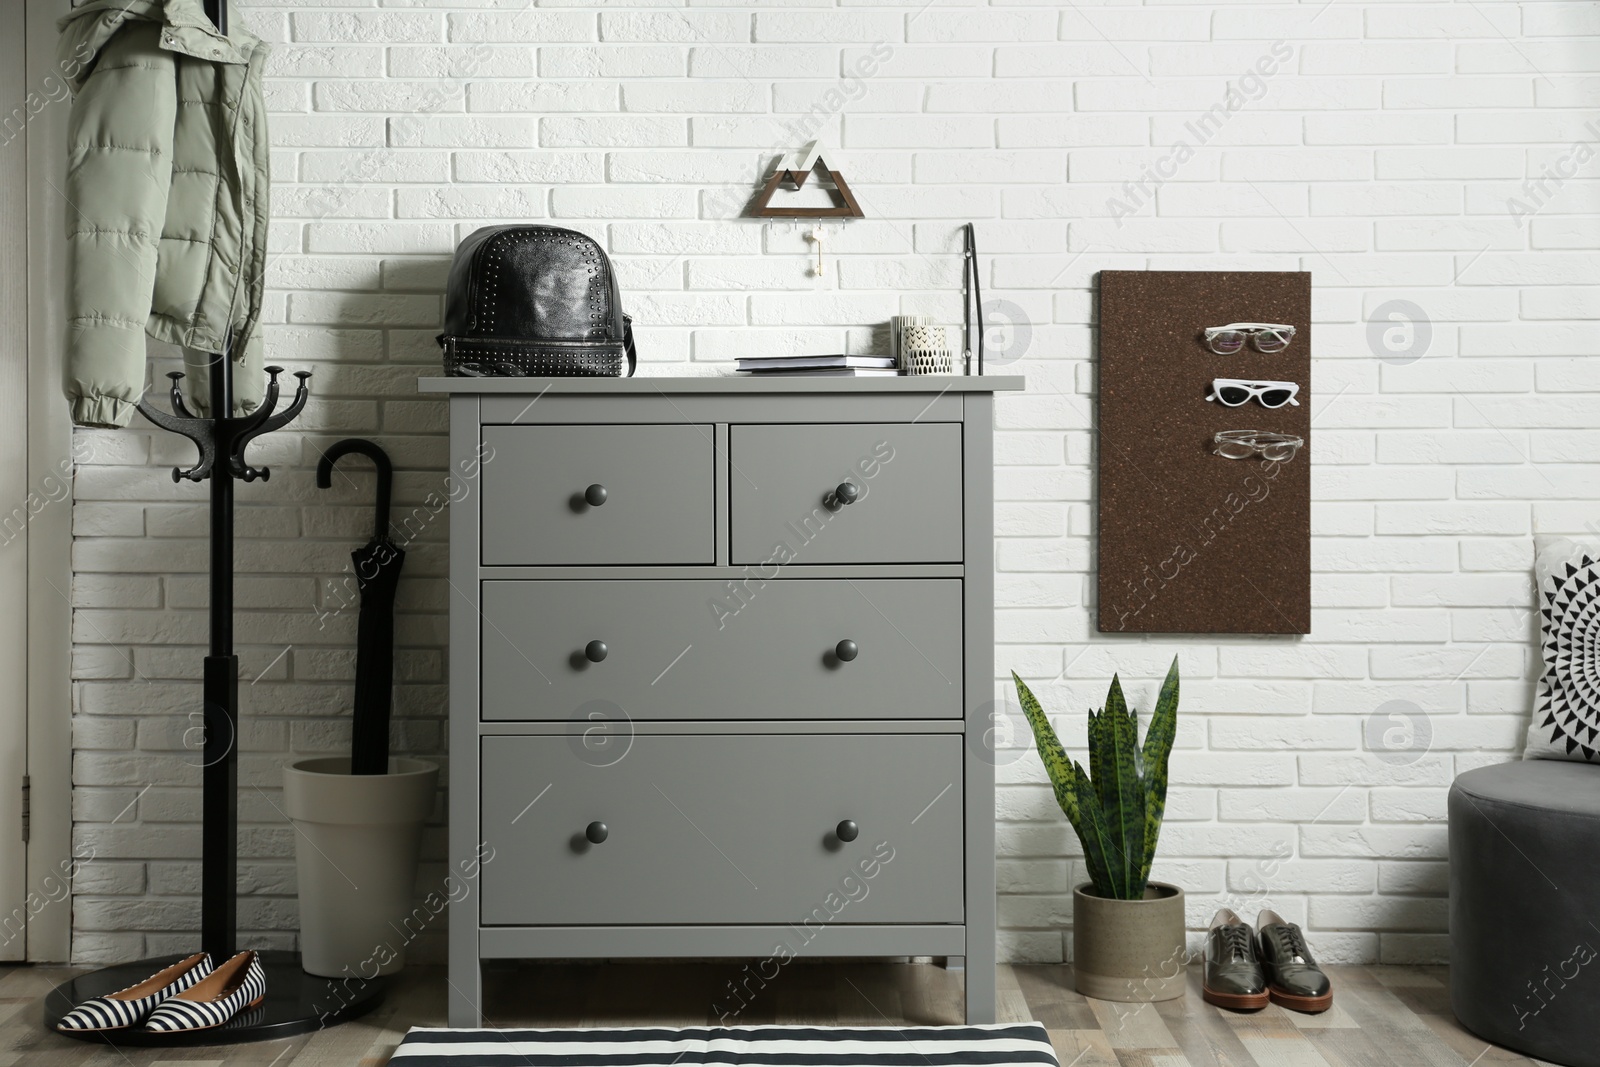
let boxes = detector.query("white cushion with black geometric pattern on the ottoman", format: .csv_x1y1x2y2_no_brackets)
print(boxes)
1523,539,1600,763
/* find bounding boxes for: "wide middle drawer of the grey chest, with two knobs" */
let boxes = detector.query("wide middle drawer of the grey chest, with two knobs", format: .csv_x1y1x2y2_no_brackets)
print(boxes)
482,577,962,720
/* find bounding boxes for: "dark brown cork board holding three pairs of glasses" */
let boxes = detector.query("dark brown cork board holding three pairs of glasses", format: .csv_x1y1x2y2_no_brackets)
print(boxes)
1098,270,1315,633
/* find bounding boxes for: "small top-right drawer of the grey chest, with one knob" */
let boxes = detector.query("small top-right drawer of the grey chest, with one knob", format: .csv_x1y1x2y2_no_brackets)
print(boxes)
728,422,962,566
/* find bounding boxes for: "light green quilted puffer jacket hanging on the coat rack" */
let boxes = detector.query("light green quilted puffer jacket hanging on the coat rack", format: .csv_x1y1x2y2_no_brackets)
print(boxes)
58,0,269,427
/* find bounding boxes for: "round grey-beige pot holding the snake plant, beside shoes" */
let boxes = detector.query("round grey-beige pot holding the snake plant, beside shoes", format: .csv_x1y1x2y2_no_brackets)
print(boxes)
1072,881,1187,1003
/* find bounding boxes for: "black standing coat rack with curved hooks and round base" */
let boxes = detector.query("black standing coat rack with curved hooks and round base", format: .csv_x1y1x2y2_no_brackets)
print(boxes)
45,0,387,1046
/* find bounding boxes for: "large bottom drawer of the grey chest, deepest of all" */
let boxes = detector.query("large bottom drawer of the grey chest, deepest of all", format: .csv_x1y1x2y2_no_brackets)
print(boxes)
480,734,965,925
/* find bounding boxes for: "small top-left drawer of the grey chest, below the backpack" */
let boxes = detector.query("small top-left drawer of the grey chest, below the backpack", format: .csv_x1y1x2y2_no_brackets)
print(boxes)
482,426,717,566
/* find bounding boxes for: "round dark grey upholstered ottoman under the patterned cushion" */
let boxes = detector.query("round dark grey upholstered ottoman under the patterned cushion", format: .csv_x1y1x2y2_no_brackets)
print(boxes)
1450,760,1600,1067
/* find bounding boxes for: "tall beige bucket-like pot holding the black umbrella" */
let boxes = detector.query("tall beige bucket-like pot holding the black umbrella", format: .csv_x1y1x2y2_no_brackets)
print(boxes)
283,757,438,977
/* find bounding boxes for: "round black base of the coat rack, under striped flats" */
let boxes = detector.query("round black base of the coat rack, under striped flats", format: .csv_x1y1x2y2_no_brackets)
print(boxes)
45,952,389,1048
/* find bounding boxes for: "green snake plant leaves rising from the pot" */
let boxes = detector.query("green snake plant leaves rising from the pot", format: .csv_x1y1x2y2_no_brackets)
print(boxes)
1011,656,1178,901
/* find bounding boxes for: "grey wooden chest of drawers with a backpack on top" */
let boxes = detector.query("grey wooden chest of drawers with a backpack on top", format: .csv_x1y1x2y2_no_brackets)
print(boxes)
421,378,1022,1025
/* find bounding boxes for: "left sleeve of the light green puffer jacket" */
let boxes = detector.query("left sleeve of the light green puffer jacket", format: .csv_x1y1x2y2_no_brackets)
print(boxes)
66,22,178,427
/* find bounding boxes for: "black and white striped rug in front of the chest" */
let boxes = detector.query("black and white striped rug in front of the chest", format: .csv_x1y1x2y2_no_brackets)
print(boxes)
389,1022,1059,1067
